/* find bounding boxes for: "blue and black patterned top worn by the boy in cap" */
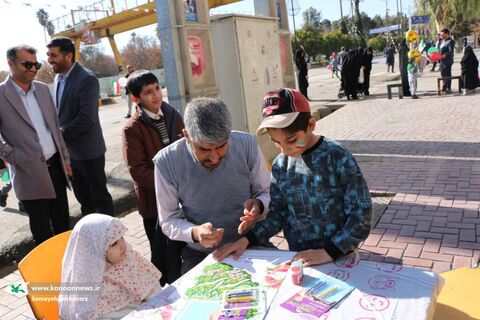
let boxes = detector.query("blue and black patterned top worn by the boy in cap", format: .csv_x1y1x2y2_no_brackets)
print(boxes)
246,137,372,259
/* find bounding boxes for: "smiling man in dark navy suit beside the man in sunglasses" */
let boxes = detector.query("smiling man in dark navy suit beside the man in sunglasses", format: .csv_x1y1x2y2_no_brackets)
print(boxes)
47,37,113,215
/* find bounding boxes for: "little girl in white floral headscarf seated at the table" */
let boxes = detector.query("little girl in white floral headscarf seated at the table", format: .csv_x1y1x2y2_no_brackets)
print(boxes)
59,214,162,319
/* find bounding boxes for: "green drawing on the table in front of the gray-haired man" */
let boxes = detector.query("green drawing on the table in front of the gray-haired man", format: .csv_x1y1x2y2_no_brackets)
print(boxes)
185,263,259,300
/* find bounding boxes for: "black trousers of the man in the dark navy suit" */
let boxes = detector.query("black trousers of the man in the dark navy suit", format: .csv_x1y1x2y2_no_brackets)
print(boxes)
71,155,113,216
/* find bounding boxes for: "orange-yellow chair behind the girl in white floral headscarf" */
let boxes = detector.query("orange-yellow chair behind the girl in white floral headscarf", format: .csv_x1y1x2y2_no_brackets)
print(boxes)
18,231,72,320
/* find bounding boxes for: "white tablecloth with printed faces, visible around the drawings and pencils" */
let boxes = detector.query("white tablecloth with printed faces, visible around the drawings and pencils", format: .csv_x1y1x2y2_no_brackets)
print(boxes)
124,250,441,320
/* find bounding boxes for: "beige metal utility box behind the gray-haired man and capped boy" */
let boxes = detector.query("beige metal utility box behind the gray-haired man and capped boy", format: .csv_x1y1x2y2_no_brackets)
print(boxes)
211,14,283,160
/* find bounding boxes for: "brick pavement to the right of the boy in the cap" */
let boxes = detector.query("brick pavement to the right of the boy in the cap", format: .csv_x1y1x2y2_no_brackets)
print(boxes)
316,94,480,272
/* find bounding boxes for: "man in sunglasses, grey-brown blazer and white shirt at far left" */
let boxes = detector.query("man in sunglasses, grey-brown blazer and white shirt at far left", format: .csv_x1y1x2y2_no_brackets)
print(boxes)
0,45,72,245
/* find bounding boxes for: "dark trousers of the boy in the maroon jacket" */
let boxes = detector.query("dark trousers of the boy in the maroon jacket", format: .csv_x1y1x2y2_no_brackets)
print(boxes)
152,224,186,286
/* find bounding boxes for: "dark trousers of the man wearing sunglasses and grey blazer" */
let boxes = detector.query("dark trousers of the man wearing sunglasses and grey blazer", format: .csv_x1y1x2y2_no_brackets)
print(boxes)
22,153,70,245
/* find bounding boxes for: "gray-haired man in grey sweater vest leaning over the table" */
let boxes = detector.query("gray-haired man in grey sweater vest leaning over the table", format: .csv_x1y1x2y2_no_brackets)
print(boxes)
153,98,270,274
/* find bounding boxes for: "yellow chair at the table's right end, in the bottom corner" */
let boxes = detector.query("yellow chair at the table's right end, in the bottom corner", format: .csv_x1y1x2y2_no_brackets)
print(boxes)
433,268,480,320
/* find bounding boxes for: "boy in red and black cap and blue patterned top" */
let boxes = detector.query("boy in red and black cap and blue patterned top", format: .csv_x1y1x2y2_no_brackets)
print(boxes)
213,88,372,267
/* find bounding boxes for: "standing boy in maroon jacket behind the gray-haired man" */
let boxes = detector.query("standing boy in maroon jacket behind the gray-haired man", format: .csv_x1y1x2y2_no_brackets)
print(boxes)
122,70,184,281
